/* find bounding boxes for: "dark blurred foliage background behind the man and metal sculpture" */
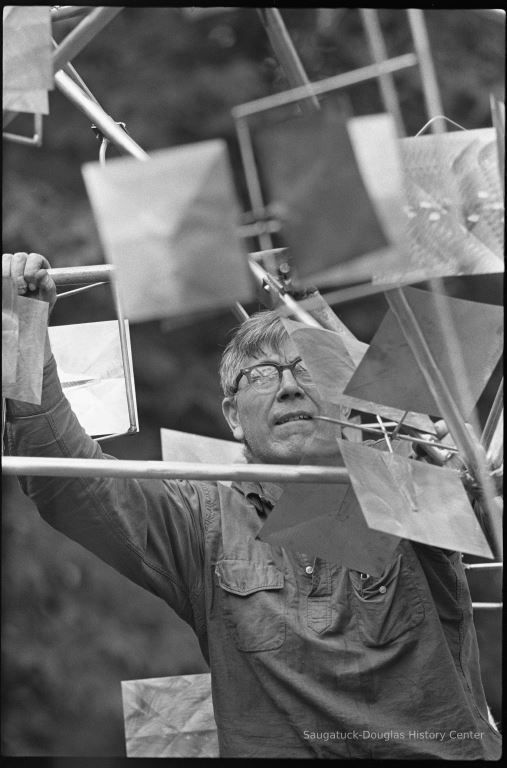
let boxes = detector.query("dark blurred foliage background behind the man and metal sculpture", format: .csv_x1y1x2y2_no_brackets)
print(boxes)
2,7,504,765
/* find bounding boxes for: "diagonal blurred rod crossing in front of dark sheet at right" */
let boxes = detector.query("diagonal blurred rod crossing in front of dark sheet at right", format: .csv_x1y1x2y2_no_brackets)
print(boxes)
386,288,502,557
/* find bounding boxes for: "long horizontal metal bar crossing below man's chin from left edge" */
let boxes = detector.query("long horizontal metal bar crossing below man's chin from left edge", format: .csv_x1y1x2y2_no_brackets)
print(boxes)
2,456,349,484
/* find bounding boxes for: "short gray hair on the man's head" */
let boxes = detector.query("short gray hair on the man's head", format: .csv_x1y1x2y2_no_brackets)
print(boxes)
220,309,289,397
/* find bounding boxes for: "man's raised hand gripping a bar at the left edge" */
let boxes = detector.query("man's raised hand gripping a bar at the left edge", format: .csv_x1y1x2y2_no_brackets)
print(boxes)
2,252,56,314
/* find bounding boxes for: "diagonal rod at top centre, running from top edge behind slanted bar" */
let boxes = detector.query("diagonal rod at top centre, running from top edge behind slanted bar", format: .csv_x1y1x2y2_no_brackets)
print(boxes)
257,8,320,112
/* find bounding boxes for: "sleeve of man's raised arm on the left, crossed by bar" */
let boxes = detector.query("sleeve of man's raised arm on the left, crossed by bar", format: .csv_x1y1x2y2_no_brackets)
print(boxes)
6,357,205,625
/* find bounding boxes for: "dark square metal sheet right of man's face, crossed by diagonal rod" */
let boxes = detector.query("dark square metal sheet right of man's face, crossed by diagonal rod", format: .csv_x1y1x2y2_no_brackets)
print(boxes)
345,288,504,419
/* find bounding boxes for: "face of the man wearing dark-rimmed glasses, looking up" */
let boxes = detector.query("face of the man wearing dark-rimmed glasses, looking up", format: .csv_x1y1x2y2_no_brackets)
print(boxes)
222,341,336,464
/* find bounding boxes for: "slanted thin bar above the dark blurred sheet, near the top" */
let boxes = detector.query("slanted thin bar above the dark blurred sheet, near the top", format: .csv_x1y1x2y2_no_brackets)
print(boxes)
231,53,417,119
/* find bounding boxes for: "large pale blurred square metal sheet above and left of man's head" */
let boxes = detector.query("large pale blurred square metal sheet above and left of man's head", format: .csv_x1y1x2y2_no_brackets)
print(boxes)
82,139,254,322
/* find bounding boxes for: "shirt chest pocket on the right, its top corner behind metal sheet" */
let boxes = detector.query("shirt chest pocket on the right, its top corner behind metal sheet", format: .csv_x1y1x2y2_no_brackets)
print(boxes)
349,555,424,647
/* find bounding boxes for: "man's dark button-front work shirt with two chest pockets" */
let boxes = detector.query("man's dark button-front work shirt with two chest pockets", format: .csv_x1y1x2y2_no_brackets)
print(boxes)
8,359,500,760
